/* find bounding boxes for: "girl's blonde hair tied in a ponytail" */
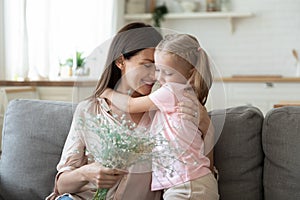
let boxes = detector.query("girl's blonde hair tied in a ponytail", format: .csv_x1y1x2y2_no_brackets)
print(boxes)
156,34,213,105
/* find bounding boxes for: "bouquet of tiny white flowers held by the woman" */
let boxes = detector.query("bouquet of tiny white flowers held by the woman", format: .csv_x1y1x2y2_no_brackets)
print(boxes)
78,114,178,200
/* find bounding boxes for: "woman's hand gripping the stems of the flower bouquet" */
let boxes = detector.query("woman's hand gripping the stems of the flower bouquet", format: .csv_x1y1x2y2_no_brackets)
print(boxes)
83,162,128,188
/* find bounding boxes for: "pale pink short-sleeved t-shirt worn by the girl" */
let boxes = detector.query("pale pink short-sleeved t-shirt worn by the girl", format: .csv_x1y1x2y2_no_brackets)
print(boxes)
149,83,210,190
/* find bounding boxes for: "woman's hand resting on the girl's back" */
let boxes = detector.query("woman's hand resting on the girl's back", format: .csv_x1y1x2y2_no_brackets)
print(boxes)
178,92,211,137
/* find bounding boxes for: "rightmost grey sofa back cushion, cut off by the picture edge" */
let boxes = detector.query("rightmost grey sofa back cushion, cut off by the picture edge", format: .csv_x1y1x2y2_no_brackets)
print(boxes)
262,107,300,200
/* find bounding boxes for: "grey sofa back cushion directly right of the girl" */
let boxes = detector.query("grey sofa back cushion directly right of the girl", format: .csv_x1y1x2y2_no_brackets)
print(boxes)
210,106,264,200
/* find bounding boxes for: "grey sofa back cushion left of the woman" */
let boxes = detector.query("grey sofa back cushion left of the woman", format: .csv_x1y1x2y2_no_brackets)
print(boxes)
0,100,74,200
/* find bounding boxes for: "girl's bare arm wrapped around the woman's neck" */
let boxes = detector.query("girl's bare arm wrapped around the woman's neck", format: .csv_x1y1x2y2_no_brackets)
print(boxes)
101,88,158,113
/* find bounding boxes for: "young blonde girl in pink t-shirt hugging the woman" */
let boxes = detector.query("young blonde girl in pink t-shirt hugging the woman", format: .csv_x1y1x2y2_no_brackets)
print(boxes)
103,34,219,200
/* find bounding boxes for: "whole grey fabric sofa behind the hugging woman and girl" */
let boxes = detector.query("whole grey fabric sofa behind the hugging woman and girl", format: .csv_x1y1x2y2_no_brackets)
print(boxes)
0,100,300,200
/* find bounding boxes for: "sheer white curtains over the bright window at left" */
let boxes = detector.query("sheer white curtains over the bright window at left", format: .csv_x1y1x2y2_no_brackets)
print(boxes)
3,0,115,79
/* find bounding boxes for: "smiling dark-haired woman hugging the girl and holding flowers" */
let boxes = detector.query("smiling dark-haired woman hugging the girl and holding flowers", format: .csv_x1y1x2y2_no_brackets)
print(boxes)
48,23,209,200
